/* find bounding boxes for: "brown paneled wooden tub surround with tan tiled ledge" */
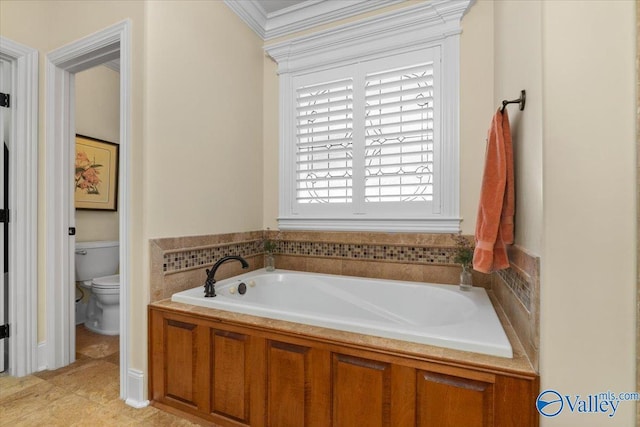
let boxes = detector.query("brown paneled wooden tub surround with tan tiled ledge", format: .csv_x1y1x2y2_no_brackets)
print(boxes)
149,294,539,427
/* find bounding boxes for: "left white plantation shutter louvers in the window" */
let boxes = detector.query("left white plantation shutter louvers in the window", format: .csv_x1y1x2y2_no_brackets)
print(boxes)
296,78,353,203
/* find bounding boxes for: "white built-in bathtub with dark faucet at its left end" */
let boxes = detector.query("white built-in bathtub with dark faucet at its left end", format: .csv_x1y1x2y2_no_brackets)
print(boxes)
171,269,513,358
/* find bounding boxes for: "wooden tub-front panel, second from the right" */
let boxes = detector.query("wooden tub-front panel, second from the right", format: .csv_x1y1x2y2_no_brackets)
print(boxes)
332,354,391,427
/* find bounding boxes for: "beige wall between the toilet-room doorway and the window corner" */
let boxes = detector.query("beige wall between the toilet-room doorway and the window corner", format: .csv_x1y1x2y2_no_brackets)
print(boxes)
145,1,264,238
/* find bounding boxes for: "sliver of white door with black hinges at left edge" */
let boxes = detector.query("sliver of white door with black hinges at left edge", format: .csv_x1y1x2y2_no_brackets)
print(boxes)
0,60,11,372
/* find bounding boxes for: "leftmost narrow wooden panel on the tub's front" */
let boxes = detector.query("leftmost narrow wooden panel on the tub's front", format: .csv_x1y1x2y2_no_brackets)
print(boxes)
164,319,198,406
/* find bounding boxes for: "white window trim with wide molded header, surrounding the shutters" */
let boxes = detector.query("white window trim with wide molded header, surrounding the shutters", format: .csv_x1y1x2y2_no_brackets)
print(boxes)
265,0,472,233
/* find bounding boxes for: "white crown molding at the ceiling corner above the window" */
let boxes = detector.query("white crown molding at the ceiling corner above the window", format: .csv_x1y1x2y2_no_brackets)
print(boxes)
224,0,405,41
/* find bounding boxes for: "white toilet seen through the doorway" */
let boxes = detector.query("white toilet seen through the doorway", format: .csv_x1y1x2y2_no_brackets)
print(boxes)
75,241,120,335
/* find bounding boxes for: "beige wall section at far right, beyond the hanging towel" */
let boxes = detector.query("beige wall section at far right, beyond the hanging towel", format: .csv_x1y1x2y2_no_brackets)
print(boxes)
540,1,636,426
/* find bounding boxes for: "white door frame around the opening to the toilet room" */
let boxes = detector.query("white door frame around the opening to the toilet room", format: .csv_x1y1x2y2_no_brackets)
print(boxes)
45,19,132,406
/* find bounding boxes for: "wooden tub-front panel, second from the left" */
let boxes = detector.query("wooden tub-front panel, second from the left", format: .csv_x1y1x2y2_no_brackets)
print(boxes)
211,330,250,422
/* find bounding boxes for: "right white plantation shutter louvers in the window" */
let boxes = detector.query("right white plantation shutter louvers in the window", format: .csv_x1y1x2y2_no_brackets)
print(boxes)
365,62,434,203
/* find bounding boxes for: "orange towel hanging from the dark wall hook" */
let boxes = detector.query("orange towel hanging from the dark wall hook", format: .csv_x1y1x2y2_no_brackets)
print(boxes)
473,110,515,273
